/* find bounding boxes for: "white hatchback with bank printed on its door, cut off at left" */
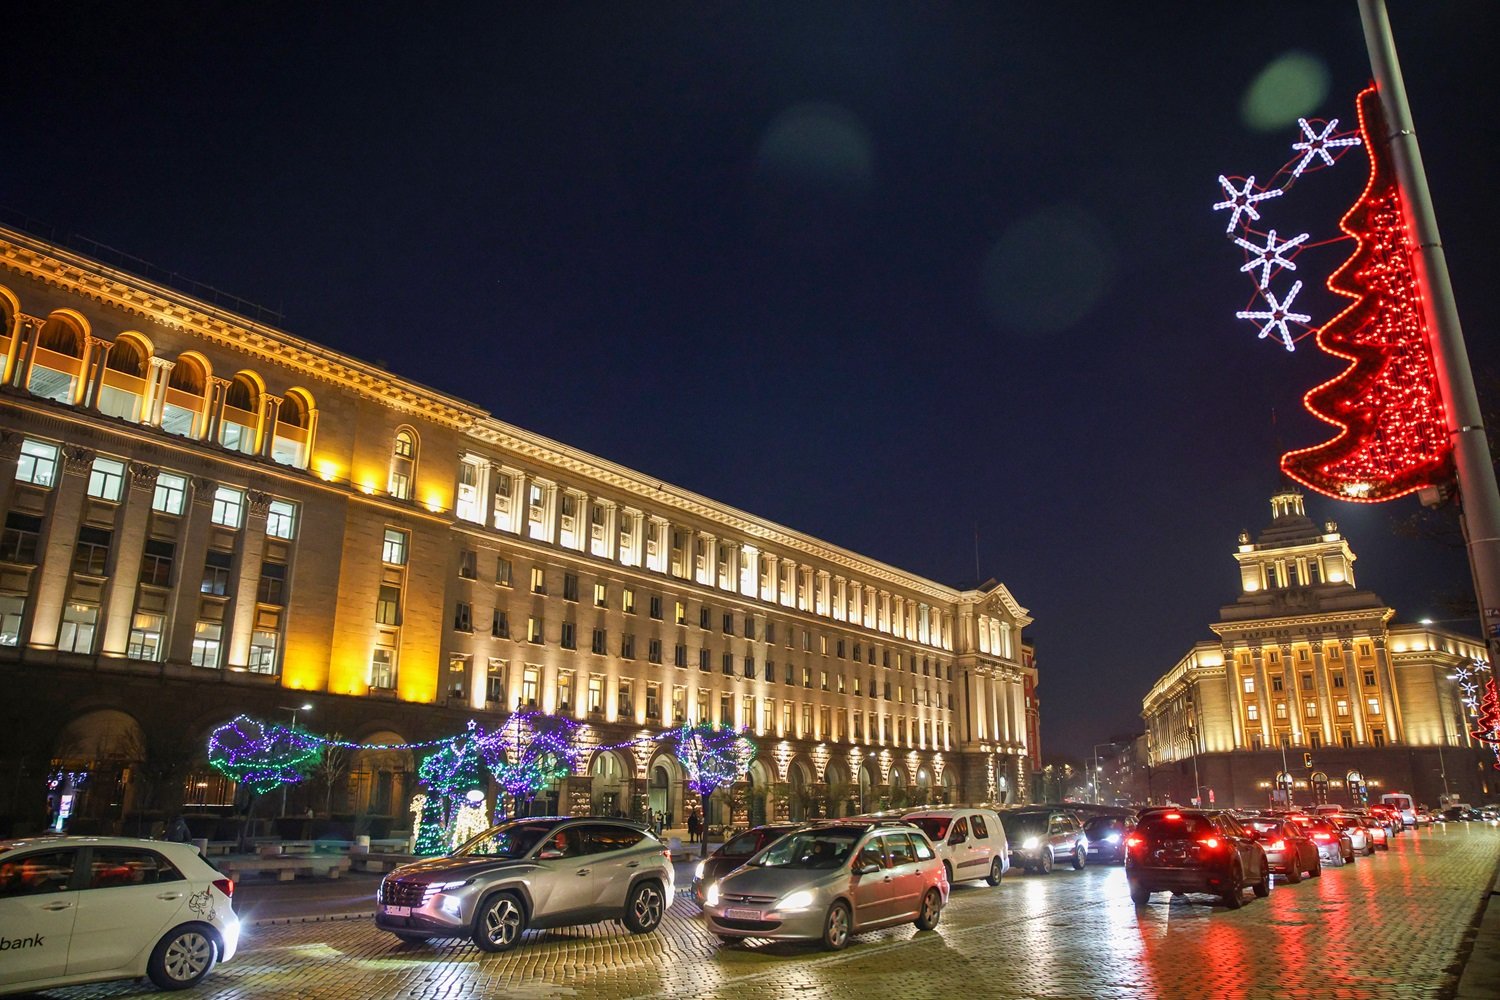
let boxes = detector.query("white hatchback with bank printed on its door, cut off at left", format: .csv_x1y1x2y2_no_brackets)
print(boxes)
0,837,240,993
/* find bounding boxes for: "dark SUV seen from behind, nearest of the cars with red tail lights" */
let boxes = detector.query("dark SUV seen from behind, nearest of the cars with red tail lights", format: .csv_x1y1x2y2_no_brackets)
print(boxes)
1125,810,1271,910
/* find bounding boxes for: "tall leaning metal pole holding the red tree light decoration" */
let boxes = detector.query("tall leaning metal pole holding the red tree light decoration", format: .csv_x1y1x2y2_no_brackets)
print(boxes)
1359,0,1500,660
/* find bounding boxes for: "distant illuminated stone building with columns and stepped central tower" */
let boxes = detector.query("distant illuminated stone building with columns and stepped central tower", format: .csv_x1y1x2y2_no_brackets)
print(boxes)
1142,489,1488,805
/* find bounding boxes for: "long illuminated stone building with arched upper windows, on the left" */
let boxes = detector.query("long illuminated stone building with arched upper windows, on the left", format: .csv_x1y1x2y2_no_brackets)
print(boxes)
0,231,1035,828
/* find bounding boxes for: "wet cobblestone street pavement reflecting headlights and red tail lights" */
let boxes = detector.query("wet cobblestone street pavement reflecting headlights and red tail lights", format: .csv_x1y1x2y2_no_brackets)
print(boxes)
26,825,1500,1000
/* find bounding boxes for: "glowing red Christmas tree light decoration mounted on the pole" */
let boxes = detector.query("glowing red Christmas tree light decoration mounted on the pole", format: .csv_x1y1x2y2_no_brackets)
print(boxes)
1281,87,1452,504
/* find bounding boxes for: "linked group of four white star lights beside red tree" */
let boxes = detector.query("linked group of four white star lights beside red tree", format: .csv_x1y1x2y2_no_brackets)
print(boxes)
1214,108,1362,351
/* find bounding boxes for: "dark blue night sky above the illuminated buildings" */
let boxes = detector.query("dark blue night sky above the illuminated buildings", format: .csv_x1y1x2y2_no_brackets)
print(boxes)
0,0,1500,754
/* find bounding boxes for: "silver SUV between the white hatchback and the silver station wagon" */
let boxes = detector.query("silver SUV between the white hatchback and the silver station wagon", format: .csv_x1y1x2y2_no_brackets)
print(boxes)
375,817,675,952
